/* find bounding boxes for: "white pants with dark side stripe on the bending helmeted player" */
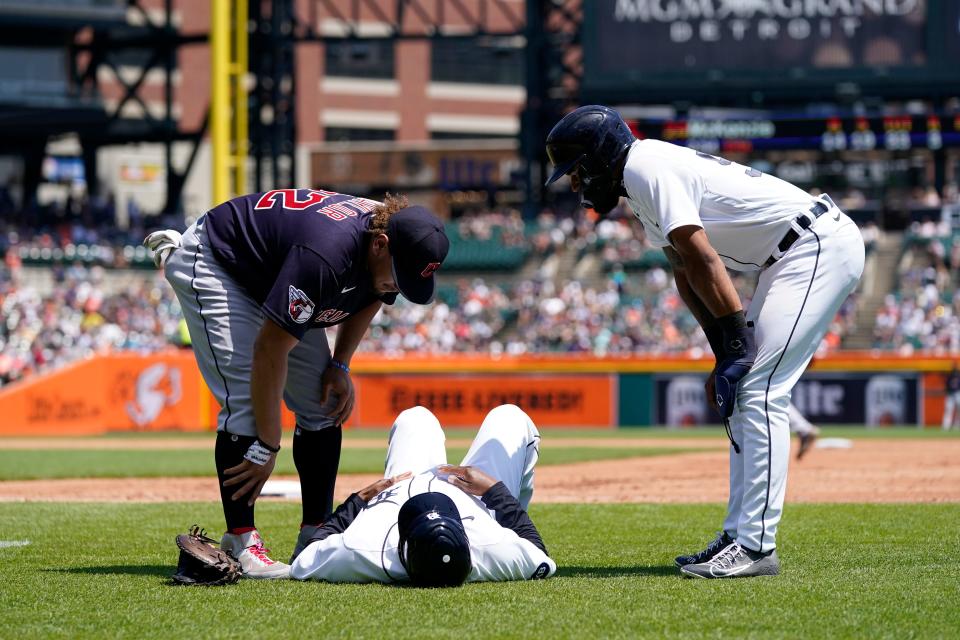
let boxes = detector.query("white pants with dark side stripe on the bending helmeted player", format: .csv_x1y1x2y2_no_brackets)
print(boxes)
723,207,864,552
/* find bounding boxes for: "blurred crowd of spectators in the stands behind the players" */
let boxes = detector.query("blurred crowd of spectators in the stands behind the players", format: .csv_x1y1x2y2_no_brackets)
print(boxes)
0,190,960,383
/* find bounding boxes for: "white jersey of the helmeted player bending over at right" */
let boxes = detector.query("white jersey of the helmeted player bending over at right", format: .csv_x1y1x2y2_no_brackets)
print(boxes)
623,140,814,271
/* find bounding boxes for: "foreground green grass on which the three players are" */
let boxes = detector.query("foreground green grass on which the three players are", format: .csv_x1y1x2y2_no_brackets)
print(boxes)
0,503,960,639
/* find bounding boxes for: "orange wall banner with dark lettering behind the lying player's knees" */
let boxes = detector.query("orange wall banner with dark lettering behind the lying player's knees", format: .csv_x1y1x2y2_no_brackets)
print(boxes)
354,374,617,428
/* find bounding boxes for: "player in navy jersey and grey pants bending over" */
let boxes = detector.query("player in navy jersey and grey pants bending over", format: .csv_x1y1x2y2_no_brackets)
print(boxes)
144,189,449,578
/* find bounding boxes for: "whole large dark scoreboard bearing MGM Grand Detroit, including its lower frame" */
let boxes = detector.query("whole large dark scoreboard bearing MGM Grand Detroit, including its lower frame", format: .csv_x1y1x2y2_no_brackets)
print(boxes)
580,0,960,105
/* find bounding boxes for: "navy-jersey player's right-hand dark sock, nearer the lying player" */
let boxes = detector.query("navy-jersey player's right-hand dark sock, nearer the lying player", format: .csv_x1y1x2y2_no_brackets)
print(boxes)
293,427,343,525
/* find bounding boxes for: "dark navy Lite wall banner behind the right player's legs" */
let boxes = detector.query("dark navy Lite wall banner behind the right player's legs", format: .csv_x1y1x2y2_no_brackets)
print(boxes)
654,372,920,427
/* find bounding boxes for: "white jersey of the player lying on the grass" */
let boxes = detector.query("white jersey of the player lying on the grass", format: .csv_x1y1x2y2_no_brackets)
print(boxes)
291,469,557,583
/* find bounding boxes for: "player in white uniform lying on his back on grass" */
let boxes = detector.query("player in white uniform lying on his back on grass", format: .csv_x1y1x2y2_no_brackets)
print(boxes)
290,405,557,587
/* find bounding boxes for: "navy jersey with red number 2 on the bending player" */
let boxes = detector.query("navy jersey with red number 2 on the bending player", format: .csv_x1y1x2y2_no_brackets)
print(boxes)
204,189,396,338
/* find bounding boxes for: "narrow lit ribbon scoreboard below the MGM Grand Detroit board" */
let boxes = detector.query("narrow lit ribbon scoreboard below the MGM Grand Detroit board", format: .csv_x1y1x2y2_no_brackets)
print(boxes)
627,114,960,153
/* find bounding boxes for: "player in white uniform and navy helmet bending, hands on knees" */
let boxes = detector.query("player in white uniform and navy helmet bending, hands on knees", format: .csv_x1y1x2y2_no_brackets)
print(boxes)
547,105,864,578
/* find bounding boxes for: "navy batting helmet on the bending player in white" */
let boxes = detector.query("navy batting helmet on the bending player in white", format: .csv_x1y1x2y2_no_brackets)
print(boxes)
547,104,636,213
